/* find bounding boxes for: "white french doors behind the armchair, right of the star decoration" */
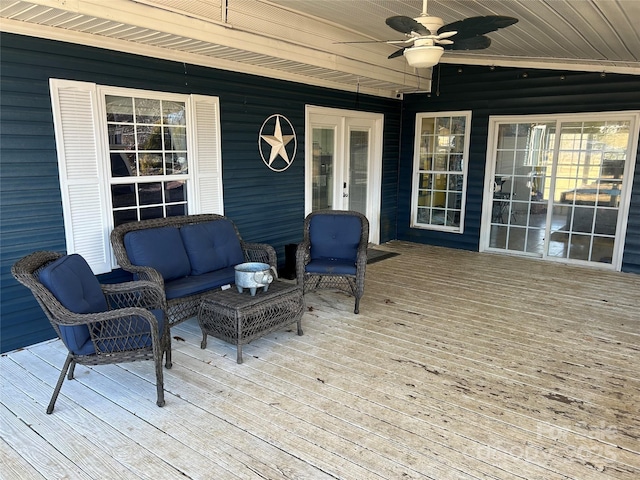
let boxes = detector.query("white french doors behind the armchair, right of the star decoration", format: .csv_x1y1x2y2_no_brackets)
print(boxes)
305,107,383,243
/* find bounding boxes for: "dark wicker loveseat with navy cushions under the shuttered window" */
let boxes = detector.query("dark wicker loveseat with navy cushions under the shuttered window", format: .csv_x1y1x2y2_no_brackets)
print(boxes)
111,214,278,336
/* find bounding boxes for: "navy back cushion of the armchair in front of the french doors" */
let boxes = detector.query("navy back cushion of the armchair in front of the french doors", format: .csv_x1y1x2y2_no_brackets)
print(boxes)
309,214,362,262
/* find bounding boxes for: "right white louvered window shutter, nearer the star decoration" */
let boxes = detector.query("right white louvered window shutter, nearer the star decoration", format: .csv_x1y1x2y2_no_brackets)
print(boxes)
189,95,224,215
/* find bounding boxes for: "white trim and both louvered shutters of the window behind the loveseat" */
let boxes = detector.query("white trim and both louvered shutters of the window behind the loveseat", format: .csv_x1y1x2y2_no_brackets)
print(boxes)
49,78,224,274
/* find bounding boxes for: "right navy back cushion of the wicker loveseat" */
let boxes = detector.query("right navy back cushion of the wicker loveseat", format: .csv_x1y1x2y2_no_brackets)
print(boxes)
180,219,244,275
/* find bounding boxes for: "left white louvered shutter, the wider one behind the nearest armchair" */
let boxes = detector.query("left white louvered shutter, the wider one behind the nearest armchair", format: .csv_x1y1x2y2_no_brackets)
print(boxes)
49,79,111,274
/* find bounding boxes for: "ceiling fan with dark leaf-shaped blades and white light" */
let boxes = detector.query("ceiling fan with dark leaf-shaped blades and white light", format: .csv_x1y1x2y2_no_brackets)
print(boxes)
386,0,518,68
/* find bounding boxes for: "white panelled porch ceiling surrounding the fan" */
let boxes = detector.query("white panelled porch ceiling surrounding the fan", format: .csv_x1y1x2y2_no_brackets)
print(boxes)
0,0,640,97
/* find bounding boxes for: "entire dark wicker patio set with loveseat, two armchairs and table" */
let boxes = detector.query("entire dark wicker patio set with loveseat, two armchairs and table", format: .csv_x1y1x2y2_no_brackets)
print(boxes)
12,211,369,413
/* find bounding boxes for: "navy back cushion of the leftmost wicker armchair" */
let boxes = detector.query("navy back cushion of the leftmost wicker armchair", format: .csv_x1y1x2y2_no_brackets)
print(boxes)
39,254,108,355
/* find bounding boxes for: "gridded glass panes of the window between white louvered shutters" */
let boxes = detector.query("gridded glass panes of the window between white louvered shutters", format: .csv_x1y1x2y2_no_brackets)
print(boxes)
105,95,189,226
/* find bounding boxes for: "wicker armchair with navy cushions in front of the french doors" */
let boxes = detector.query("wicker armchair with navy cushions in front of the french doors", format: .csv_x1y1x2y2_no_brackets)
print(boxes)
296,210,369,313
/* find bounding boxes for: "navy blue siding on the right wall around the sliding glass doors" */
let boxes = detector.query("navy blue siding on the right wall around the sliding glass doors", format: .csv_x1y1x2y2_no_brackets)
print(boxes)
398,65,640,273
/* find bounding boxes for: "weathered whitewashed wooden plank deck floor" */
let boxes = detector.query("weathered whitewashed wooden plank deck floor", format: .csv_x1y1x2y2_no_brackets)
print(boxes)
0,242,640,480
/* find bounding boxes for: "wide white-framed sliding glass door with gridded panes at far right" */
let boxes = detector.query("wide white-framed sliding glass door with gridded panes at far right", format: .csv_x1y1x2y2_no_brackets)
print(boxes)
480,112,640,270
